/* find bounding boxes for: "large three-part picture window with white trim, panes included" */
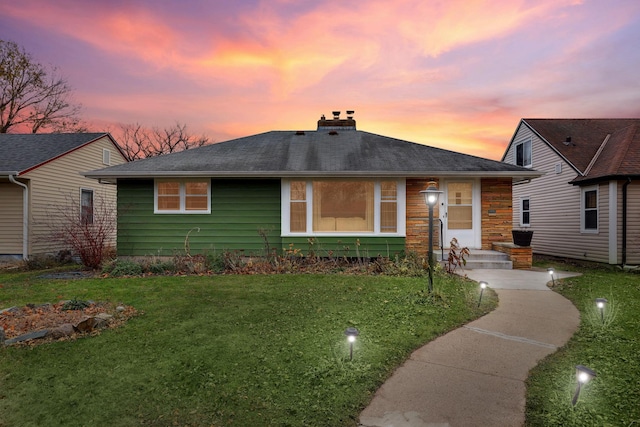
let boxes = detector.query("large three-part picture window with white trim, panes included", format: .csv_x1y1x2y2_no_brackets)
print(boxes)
282,179,405,235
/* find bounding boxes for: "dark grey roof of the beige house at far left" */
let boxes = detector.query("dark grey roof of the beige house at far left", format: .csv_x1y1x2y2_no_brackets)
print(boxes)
0,133,124,175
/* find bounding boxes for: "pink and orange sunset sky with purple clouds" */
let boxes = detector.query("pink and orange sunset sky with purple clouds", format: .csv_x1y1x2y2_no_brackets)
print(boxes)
0,0,640,159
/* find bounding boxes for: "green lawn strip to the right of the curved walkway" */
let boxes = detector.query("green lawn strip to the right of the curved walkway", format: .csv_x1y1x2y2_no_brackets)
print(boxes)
526,265,640,427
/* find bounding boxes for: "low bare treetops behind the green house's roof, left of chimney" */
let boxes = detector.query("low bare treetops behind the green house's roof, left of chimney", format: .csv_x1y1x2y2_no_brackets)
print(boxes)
112,122,211,160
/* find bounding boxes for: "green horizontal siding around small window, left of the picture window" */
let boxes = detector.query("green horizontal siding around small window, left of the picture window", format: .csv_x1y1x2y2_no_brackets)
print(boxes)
118,179,281,256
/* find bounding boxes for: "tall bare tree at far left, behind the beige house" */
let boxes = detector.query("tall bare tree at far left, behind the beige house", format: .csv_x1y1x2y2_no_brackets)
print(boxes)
0,40,85,133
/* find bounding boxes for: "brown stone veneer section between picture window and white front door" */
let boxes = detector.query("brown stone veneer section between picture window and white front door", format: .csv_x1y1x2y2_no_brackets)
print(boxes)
405,178,440,256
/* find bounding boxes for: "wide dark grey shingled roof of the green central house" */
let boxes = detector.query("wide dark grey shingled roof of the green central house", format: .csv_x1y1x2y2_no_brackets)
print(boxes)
84,128,541,179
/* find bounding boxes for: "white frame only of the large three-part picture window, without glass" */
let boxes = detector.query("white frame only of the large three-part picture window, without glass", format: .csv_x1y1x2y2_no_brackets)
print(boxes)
280,178,407,237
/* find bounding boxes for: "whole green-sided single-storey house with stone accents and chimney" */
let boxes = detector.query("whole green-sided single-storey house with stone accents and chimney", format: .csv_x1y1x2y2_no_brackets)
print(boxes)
84,111,539,257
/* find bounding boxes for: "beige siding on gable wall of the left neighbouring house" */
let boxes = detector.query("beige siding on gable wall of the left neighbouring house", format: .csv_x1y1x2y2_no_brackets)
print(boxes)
24,136,126,254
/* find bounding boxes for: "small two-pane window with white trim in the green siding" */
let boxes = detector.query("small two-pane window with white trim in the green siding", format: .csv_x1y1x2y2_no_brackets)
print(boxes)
154,179,211,214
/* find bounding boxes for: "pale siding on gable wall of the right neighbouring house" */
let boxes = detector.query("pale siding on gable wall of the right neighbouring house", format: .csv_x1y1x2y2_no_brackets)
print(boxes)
504,125,609,262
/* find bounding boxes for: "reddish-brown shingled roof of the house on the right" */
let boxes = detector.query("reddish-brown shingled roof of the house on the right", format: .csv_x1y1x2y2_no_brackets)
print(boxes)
510,119,640,184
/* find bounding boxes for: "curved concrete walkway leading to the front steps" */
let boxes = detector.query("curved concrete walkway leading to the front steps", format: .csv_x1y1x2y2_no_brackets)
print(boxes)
360,270,580,427
